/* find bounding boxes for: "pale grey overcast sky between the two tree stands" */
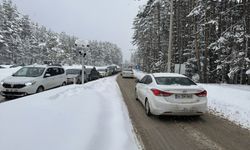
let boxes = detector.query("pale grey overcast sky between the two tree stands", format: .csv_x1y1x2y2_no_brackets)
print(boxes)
0,0,146,59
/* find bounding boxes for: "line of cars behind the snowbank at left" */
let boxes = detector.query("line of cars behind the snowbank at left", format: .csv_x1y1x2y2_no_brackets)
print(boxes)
0,65,121,99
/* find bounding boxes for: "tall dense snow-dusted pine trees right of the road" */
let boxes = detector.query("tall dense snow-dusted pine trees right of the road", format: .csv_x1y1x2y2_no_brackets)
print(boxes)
132,0,250,84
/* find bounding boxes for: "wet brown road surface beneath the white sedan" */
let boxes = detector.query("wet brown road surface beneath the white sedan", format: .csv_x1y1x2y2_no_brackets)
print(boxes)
117,76,250,150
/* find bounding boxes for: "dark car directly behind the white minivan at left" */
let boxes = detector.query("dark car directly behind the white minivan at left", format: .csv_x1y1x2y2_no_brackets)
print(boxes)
66,69,87,84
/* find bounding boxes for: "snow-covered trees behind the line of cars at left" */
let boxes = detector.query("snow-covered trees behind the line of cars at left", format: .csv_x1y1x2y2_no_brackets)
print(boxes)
0,0,122,66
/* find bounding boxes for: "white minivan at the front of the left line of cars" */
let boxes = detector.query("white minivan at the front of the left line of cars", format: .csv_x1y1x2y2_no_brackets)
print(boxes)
0,65,67,98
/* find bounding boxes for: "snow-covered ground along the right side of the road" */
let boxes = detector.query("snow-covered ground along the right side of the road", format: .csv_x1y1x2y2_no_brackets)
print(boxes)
134,70,250,129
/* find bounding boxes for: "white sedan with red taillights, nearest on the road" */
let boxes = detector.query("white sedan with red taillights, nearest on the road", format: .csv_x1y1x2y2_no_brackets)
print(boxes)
135,73,207,116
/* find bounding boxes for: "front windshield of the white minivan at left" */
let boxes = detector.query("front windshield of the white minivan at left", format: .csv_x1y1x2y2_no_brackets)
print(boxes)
13,67,45,77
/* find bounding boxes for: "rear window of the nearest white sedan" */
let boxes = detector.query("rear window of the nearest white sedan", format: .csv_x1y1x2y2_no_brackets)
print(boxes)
155,77,196,86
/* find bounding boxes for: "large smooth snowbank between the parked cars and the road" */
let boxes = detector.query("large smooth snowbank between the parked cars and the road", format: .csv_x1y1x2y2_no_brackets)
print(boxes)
0,77,138,150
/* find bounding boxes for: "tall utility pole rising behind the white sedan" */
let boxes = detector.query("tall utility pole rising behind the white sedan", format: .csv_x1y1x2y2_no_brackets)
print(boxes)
168,0,174,73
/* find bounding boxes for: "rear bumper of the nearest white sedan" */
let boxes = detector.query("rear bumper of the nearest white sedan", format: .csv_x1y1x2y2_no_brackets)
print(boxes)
150,101,207,116
